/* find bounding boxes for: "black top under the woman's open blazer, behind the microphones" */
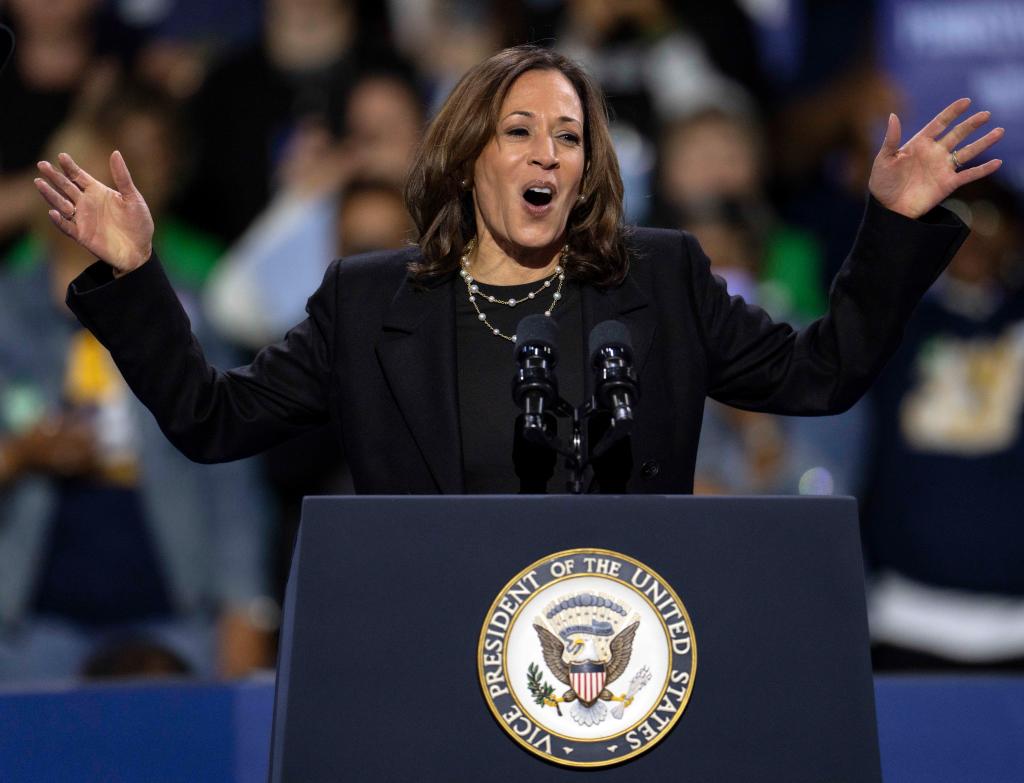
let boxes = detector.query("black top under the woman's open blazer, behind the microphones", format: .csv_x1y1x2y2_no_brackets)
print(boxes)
455,279,585,494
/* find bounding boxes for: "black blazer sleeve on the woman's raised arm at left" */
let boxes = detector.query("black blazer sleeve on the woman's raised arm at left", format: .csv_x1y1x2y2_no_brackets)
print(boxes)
67,256,337,463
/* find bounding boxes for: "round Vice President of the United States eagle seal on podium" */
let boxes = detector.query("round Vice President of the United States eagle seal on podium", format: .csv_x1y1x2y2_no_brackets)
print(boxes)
477,549,697,767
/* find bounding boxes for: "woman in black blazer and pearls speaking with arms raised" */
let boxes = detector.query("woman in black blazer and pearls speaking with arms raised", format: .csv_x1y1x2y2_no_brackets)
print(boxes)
29,46,1002,493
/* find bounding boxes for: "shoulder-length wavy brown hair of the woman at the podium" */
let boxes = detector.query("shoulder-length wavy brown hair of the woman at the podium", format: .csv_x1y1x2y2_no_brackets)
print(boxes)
406,45,629,287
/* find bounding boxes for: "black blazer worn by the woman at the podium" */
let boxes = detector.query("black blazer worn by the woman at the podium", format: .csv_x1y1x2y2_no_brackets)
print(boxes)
68,201,967,493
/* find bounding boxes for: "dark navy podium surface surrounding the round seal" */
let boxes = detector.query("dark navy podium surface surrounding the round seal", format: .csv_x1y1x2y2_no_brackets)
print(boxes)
270,495,881,783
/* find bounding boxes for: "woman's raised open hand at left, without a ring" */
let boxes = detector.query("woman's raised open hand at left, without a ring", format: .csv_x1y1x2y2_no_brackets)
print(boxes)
35,151,153,276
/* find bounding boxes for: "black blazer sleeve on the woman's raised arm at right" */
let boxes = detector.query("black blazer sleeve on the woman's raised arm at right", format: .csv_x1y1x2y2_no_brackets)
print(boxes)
687,199,968,416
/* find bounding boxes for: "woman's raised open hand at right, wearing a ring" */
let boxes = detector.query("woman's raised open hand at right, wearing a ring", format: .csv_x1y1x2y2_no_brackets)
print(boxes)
867,98,1004,218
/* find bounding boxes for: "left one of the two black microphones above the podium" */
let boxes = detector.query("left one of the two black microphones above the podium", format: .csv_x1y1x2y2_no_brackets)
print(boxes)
512,315,558,433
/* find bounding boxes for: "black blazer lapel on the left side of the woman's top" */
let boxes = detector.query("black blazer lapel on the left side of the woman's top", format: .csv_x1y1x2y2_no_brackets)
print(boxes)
377,274,465,494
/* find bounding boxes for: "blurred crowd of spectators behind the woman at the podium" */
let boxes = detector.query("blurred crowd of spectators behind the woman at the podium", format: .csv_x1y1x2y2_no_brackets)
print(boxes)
0,0,1024,683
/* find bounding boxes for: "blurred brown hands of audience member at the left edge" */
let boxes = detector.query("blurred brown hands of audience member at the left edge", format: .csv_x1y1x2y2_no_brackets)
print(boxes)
2,415,99,481
